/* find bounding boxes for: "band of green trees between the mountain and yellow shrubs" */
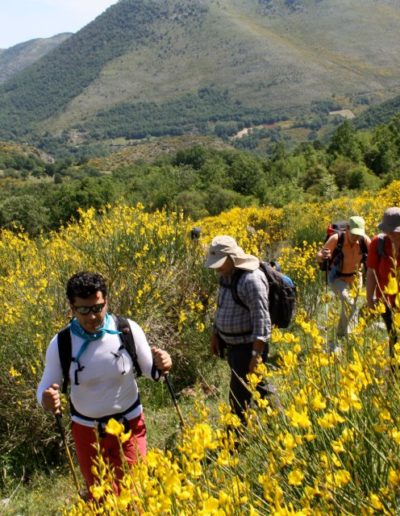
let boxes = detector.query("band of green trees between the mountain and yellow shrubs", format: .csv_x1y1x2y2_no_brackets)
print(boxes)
0,115,400,234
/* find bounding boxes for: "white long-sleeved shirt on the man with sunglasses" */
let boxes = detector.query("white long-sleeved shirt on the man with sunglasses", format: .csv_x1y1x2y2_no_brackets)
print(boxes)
36,319,159,427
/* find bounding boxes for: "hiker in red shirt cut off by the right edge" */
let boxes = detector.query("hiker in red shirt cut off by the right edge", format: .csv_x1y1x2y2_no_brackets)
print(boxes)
367,206,400,357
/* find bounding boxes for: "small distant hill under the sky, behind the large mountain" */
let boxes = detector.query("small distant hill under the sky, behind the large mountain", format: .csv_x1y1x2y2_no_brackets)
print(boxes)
0,33,71,84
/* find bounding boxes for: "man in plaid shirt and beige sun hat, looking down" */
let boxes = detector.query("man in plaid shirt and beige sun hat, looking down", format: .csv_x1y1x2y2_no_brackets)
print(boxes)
205,235,275,422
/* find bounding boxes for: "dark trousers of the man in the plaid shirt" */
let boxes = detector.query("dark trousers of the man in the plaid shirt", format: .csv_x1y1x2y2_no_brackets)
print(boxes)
227,342,276,423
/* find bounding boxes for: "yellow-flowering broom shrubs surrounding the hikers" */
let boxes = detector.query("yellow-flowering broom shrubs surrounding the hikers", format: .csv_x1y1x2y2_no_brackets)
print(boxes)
0,177,400,514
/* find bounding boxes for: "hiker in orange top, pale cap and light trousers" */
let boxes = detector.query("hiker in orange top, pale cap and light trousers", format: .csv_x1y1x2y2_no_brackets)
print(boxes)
317,215,371,338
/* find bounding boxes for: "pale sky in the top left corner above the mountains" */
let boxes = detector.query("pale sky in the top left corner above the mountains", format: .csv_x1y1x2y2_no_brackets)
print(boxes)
0,0,117,49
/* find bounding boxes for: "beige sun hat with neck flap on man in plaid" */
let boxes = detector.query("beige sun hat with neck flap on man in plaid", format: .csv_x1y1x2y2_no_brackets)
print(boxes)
204,235,260,271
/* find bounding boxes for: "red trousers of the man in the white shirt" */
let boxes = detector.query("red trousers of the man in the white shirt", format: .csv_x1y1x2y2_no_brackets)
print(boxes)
71,413,146,493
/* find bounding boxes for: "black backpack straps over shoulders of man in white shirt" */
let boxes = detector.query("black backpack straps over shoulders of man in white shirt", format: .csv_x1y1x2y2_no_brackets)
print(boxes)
57,315,142,394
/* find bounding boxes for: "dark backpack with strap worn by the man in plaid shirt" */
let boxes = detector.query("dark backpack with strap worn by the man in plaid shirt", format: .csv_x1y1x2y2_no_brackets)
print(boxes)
230,262,296,328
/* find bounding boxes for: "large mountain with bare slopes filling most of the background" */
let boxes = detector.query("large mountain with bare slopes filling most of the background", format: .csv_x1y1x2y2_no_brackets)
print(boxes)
0,0,400,140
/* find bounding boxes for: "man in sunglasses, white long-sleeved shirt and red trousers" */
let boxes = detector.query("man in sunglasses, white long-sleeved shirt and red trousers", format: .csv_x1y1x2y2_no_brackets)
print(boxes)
37,272,171,492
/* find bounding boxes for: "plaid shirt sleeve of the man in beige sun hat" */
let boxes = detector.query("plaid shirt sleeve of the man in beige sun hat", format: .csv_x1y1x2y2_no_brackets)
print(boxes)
238,269,271,342
